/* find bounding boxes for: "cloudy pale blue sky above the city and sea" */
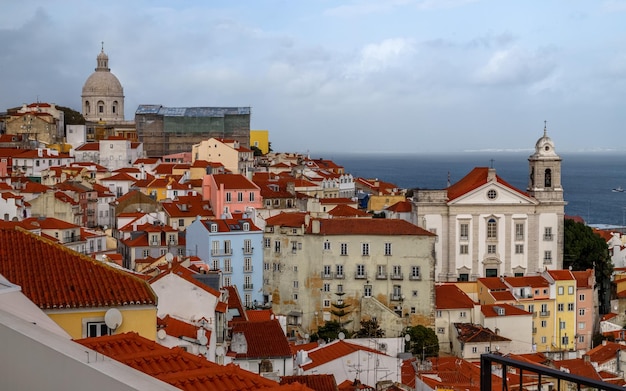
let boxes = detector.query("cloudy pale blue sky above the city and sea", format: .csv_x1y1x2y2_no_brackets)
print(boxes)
0,0,626,154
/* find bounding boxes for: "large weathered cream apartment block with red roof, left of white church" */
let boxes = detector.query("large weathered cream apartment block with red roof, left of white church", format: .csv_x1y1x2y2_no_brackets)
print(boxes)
263,213,435,337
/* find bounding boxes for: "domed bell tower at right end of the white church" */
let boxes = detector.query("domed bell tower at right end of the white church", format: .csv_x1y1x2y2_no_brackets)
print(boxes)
527,124,563,203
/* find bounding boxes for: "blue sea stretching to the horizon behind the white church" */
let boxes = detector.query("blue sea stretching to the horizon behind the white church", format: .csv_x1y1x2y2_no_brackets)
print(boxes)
320,150,626,226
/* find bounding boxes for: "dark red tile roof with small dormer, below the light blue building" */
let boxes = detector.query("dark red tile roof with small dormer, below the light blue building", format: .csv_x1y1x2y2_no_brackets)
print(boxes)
230,319,292,359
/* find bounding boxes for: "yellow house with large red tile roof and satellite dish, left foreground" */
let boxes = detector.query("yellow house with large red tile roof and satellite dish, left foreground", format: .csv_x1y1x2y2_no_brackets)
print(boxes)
0,229,157,340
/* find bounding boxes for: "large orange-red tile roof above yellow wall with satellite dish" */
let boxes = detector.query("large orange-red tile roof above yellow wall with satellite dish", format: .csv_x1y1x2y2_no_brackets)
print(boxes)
0,230,157,310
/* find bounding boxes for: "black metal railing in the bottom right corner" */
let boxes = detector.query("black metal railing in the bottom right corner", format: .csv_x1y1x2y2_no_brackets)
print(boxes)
480,353,624,391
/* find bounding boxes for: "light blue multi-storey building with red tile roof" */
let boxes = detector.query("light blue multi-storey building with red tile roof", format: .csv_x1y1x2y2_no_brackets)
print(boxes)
186,218,263,308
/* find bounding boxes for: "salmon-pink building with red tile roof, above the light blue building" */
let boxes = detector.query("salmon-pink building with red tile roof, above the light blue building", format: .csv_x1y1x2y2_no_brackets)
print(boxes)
202,174,263,216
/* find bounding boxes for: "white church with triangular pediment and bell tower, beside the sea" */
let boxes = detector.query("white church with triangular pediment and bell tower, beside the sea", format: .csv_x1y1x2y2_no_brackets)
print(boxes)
413,129,565,281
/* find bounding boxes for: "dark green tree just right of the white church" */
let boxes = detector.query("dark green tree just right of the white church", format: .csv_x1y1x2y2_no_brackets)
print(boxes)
563,219,613,314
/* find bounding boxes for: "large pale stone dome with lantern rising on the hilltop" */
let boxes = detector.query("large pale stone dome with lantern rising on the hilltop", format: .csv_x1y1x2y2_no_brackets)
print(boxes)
81,46,124,122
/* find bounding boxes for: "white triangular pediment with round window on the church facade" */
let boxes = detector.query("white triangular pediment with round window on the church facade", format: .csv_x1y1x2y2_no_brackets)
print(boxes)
449,182,537,206
